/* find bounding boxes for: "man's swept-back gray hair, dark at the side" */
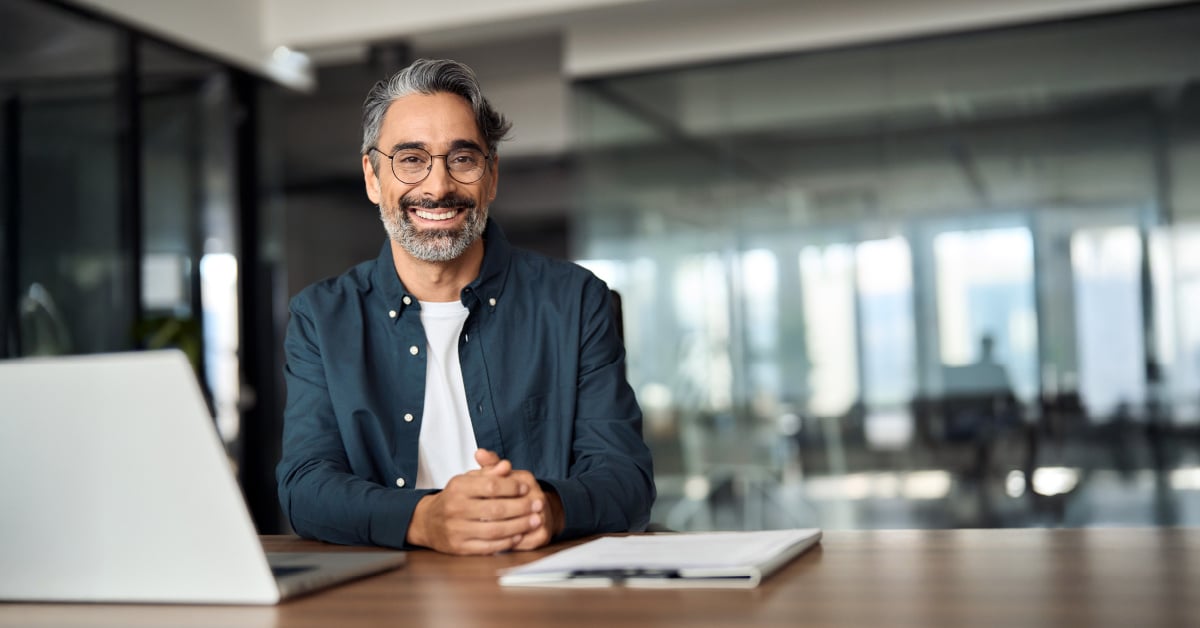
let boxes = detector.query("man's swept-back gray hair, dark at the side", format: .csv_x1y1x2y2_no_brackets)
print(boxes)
362,59,512,172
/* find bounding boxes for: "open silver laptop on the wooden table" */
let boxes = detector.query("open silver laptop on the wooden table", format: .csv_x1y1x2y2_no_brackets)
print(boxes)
0,351,404,604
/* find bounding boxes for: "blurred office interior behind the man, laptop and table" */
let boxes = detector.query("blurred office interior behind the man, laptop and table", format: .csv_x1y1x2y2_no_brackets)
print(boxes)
0,0,1200,533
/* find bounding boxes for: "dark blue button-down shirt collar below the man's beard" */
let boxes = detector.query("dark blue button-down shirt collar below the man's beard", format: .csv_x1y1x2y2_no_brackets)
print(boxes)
372,217,512,318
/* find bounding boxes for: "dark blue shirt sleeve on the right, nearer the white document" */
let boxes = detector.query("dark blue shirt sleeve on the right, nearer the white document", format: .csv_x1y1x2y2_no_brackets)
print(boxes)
542,277,655,539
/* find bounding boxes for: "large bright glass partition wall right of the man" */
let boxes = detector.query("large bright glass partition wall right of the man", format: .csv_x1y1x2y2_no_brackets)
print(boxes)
574,5,1200,530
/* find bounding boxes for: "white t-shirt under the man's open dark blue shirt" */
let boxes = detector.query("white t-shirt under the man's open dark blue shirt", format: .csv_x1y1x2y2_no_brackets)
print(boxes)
416,301,479,489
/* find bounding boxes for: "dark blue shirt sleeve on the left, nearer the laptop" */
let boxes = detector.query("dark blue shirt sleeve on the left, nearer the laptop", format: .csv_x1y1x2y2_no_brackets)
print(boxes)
276,295,432,548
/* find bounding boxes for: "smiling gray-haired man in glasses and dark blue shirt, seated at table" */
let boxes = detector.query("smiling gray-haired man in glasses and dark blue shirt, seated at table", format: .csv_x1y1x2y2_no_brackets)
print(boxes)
277,59,655,554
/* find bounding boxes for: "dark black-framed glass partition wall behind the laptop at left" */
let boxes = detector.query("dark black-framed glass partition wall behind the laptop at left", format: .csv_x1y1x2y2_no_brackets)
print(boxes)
0,0,280,532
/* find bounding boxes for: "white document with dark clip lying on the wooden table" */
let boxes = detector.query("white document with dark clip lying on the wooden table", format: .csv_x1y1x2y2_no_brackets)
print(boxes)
500,528,821,588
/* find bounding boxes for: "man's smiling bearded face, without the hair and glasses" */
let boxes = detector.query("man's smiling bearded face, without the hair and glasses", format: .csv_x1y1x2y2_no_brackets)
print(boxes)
362,94,497,262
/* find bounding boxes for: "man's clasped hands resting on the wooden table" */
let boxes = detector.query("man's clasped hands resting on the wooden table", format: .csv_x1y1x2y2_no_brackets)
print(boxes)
408,449,563,555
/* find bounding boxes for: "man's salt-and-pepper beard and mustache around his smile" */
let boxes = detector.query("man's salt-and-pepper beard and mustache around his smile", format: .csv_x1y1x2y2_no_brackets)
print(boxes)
379,195,487,262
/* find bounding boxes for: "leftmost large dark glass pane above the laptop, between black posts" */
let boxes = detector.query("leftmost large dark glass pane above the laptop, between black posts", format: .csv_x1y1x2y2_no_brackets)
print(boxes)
9,2,127,354
